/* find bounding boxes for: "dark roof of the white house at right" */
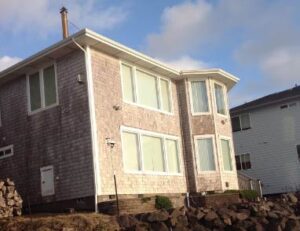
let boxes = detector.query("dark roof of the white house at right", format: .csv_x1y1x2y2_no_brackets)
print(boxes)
230,86,300,114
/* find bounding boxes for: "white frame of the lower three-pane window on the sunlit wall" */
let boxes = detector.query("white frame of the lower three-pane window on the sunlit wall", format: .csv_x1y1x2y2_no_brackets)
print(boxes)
120,126,183,176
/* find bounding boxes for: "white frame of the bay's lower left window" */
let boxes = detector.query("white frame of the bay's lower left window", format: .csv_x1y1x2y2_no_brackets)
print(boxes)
194,134,218,175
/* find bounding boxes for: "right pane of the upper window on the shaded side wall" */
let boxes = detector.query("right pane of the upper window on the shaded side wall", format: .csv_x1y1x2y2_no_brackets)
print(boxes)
44,66,56,107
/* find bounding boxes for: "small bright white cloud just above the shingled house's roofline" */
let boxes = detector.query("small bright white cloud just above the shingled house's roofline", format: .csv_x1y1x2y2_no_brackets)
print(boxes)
161,55,210,70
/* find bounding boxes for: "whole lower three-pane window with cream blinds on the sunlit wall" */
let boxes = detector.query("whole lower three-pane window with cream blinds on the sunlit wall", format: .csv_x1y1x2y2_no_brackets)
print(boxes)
121,127,180,174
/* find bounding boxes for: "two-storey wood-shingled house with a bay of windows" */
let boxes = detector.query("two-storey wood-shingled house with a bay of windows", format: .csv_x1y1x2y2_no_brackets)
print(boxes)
0,29,238,211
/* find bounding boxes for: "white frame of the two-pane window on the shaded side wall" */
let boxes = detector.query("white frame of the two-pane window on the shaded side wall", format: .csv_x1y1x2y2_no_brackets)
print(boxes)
26,62,59,115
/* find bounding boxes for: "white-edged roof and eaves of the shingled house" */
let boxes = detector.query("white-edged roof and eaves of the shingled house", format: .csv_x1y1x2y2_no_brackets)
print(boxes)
0,29,239,90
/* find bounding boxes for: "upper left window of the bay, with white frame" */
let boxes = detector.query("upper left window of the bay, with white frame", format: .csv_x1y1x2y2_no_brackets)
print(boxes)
189,79,210,115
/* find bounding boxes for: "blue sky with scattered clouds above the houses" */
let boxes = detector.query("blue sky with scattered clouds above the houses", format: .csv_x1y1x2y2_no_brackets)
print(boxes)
0,0,300,106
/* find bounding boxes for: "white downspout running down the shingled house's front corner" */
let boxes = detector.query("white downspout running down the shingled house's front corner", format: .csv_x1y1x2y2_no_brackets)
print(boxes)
72,38,100,213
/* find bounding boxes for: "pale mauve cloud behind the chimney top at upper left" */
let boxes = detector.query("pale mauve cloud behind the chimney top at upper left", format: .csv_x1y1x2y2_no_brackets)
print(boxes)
0,0,127,35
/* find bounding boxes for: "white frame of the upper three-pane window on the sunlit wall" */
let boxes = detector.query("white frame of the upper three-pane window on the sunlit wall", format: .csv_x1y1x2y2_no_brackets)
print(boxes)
120,61,174,115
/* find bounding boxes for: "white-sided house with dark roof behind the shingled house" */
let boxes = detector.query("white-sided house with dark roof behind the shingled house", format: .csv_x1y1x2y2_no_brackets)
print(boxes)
231,86,300,194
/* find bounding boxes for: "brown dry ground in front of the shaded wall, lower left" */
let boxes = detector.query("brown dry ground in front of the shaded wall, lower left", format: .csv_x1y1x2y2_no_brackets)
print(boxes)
0,213,119,231
